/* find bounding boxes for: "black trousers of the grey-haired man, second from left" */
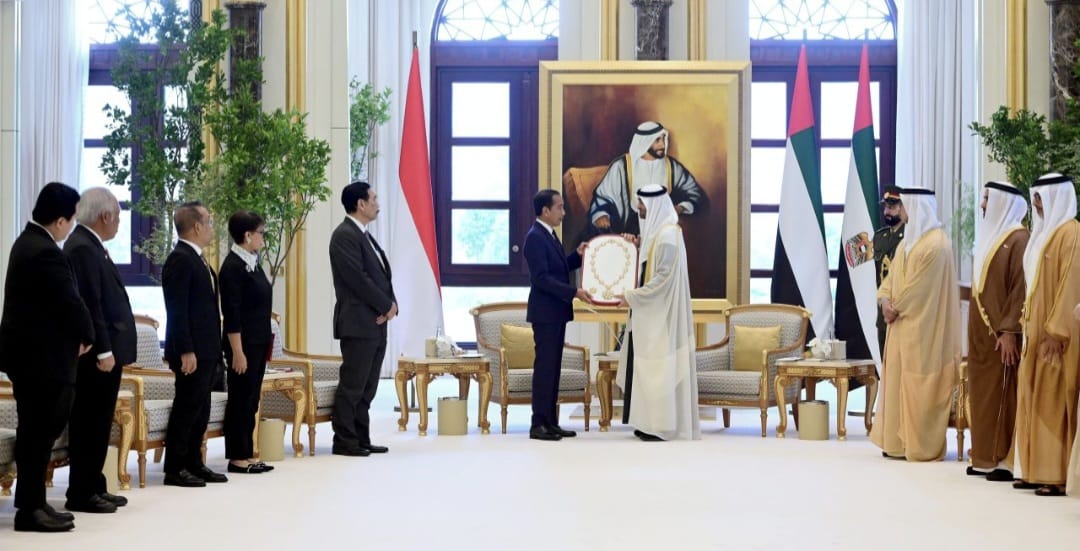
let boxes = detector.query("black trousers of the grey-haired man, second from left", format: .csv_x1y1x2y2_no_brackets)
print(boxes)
67,354,123,500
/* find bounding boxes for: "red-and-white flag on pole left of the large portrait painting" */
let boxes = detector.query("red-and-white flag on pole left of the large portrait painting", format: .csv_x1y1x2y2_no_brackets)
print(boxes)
383,48,443,371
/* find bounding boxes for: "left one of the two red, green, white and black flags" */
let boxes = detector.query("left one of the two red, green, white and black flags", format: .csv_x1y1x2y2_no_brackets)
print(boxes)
772,45,833,336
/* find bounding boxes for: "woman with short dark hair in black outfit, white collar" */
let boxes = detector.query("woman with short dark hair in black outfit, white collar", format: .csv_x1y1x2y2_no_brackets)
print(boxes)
218,211,273,474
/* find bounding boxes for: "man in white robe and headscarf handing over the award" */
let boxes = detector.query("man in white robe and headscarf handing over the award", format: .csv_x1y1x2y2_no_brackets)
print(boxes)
616,185,701,442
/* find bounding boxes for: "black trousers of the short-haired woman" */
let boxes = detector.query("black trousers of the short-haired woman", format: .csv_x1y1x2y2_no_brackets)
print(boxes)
225,342,267,460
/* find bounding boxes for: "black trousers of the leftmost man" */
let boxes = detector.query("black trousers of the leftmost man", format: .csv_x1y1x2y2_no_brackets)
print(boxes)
11,375,75,511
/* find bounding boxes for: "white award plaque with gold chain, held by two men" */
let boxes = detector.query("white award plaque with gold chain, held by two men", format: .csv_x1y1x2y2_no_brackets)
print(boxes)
581,234,638,305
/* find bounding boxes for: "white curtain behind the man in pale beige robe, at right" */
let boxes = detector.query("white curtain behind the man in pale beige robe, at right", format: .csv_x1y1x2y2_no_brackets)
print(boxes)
896,0,978,279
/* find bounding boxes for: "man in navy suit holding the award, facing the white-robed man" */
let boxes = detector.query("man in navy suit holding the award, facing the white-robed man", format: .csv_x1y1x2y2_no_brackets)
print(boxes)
525,189,590,440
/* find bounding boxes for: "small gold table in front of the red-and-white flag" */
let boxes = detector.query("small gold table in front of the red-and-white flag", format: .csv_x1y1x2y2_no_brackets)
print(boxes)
394,357,491,436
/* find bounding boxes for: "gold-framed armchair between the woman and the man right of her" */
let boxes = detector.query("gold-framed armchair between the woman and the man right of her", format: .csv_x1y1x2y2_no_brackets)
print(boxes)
259,312,341,455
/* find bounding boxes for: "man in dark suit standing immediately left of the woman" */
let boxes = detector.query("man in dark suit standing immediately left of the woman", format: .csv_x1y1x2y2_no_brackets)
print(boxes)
161,202,228,487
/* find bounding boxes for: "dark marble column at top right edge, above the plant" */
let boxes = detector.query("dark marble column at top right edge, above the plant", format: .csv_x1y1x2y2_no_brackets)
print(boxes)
1047,0,1080,119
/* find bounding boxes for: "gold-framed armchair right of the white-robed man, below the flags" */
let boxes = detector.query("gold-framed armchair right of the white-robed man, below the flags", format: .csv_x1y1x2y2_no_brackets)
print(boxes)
696,305,810,438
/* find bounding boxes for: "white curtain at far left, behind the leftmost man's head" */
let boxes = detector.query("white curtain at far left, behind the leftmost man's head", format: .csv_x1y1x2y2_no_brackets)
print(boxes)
18,0,90,224
